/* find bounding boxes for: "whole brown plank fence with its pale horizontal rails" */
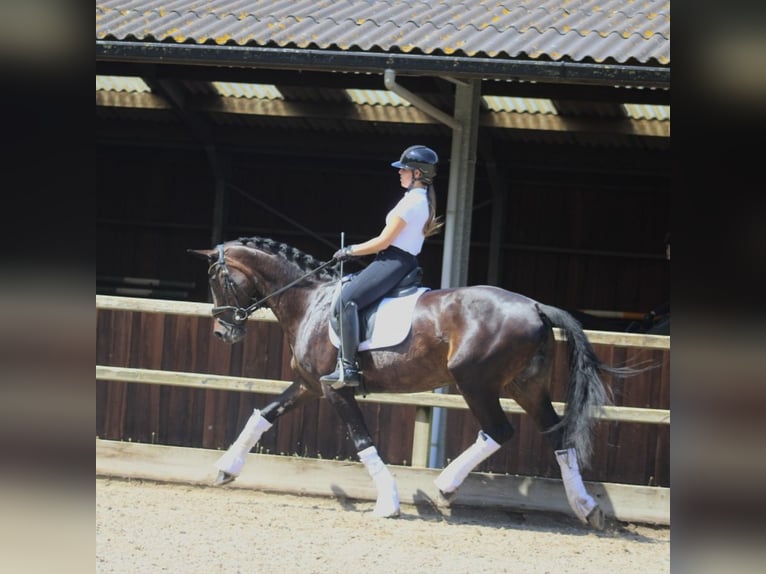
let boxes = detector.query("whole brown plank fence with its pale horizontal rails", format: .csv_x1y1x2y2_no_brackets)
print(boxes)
96,295,670,486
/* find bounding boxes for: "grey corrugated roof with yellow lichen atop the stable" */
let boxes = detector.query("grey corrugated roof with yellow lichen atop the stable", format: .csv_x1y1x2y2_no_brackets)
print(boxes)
96,0,670,66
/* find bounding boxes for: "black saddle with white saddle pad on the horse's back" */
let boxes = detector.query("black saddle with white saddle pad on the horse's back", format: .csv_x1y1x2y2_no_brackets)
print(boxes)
329,267,429,351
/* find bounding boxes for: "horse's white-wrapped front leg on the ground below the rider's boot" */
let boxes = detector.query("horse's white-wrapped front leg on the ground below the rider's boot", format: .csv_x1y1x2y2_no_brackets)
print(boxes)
323,385,399,518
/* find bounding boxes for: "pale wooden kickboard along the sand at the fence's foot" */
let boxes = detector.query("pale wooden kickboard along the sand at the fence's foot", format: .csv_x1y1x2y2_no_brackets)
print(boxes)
96,438,670,525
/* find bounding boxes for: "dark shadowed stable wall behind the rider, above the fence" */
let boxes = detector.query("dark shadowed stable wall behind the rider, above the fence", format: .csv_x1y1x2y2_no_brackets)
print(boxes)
96,140,670,331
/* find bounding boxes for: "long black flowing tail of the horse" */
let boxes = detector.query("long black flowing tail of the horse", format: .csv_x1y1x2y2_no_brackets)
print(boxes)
537,303,634,468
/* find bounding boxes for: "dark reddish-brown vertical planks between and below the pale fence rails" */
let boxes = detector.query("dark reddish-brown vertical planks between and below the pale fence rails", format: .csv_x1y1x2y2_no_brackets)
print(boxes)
96,309,670,486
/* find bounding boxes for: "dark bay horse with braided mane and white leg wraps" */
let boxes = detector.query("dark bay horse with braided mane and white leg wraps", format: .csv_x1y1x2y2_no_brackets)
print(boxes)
189,237,636,529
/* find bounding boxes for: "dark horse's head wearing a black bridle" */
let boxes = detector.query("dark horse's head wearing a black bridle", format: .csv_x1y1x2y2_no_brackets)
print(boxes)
187,245,253,344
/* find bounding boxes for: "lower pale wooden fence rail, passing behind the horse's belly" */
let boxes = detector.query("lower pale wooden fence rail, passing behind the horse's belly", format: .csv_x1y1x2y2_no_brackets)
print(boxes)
96,365,670,425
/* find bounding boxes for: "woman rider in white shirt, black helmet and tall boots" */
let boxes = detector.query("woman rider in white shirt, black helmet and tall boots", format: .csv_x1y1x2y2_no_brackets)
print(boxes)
319,145,444,389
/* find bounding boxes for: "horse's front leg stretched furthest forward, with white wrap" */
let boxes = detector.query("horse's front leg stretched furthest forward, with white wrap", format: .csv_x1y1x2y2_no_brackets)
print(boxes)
213,381,318,486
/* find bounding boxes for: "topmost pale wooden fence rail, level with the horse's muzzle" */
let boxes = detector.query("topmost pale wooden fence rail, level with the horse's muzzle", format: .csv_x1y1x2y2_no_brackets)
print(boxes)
96,295,670,349
